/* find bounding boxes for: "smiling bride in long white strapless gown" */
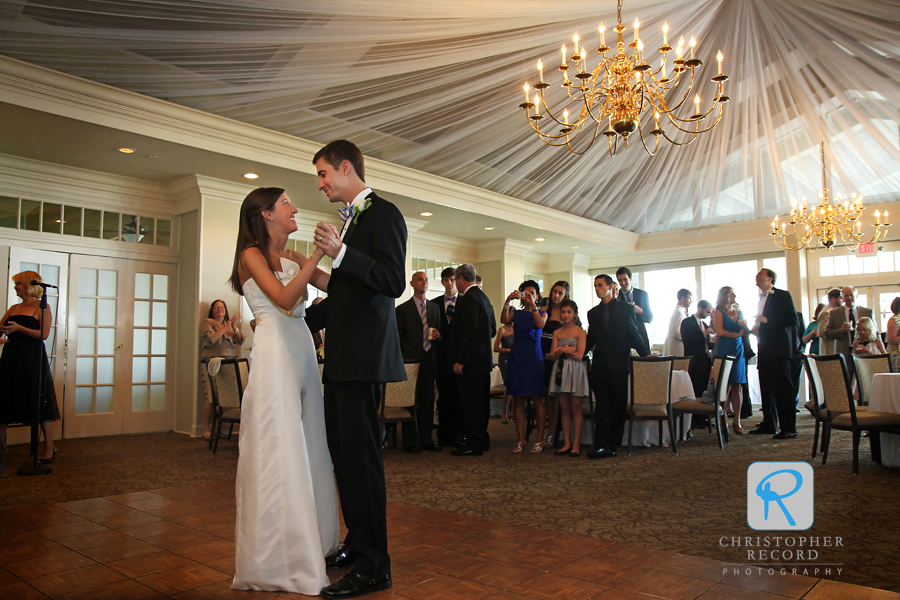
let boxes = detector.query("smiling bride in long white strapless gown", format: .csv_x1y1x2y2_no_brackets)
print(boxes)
231,188,340,595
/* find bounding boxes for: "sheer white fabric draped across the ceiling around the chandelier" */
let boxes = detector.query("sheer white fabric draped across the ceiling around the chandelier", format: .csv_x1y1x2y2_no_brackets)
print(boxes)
0,0,900,233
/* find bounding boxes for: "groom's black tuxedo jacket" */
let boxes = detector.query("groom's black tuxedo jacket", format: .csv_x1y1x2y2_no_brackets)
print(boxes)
306,192,406,383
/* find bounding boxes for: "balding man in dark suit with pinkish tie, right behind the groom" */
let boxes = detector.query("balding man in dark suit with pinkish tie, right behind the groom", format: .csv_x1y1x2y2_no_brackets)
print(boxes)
397,271,441,452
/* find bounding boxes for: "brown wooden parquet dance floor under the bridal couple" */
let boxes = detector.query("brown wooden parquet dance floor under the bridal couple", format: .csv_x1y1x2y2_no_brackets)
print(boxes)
0,480,900,600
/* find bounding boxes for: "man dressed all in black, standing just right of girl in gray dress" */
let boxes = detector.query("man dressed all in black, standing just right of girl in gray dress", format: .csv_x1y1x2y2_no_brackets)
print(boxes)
585,275,650,458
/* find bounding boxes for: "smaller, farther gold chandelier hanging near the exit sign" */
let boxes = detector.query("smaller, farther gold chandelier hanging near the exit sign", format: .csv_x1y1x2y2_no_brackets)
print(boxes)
770,143,891,252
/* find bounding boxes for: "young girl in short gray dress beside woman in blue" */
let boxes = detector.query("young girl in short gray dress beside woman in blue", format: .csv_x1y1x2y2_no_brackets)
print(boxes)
550,300,590,456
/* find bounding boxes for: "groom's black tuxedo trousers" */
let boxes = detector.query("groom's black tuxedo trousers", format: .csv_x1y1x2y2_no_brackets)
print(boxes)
325,378,391,578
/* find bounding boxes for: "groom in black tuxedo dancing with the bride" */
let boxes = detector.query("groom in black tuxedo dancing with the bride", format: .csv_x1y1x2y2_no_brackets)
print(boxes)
306,140,407,599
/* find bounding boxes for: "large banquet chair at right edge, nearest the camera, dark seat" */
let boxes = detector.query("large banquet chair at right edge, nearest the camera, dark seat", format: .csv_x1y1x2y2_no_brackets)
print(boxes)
808,354,900,475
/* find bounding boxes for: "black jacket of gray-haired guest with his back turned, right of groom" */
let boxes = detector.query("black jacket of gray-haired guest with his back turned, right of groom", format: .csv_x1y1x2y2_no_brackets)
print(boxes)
446,285,497,373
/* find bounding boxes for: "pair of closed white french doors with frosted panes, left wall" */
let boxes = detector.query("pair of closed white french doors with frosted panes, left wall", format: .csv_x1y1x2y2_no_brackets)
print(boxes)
64,254,175,438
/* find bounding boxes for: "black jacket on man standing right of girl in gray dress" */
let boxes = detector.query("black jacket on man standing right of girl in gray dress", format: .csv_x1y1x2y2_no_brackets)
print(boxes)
585,301,650,375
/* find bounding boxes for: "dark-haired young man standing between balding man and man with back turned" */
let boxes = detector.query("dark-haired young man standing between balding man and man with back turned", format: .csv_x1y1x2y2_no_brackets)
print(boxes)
432,267,463,446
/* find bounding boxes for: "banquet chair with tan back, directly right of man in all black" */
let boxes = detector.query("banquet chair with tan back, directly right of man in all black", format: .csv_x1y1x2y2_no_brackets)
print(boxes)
628,356,678,456
